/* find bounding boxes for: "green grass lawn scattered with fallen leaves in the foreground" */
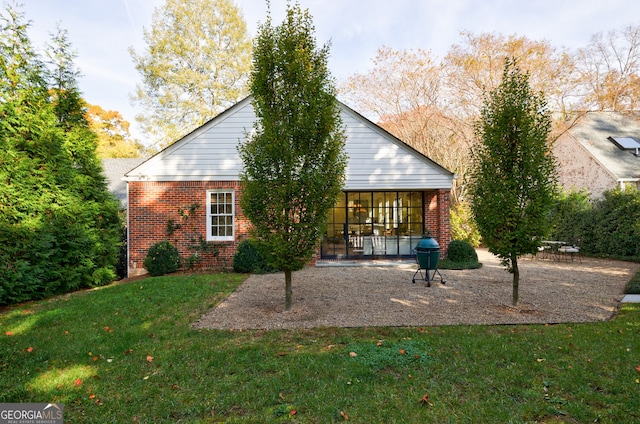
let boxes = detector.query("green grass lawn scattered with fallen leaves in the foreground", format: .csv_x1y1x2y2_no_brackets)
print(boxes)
0,274,640,423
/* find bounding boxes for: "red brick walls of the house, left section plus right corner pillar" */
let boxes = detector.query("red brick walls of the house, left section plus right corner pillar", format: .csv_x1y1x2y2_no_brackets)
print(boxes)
128,181,451,277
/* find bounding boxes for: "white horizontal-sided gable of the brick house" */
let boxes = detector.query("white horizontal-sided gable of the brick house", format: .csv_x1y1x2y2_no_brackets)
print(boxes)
126,97,453,190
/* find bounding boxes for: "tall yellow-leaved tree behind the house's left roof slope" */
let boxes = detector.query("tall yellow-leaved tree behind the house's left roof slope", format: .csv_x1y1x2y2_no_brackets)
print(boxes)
130,0,251,146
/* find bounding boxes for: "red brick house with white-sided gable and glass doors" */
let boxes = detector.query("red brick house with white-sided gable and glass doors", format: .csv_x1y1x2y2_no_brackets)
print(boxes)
125,97,454,276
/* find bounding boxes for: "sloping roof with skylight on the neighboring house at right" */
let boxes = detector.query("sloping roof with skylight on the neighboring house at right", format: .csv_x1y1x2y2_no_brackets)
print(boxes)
569,112,640,179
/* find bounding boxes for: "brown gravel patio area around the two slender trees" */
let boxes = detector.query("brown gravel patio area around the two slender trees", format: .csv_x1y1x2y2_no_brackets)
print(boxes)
194,249,640,330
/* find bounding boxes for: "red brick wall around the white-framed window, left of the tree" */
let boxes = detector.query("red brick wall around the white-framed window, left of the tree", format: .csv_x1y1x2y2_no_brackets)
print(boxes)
129,181,249,277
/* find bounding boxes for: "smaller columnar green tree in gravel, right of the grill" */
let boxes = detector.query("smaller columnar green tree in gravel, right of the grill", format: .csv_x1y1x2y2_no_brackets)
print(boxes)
469,59,557,306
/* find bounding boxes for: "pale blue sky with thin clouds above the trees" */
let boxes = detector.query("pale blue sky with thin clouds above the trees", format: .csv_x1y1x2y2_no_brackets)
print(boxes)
13,0,640,143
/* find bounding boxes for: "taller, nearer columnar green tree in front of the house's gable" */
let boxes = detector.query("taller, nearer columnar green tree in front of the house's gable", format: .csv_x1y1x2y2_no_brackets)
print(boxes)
239,1,346,310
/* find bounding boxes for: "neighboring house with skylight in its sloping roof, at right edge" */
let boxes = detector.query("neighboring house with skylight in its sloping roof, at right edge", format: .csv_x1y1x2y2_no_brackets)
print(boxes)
553,112,640,199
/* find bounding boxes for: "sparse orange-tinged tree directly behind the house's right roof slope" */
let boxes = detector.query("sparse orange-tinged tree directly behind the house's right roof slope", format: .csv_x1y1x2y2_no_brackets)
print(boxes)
340,47,472,203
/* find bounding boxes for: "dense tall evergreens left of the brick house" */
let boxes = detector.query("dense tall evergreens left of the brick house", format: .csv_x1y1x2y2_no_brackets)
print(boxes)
0,7,121,305
